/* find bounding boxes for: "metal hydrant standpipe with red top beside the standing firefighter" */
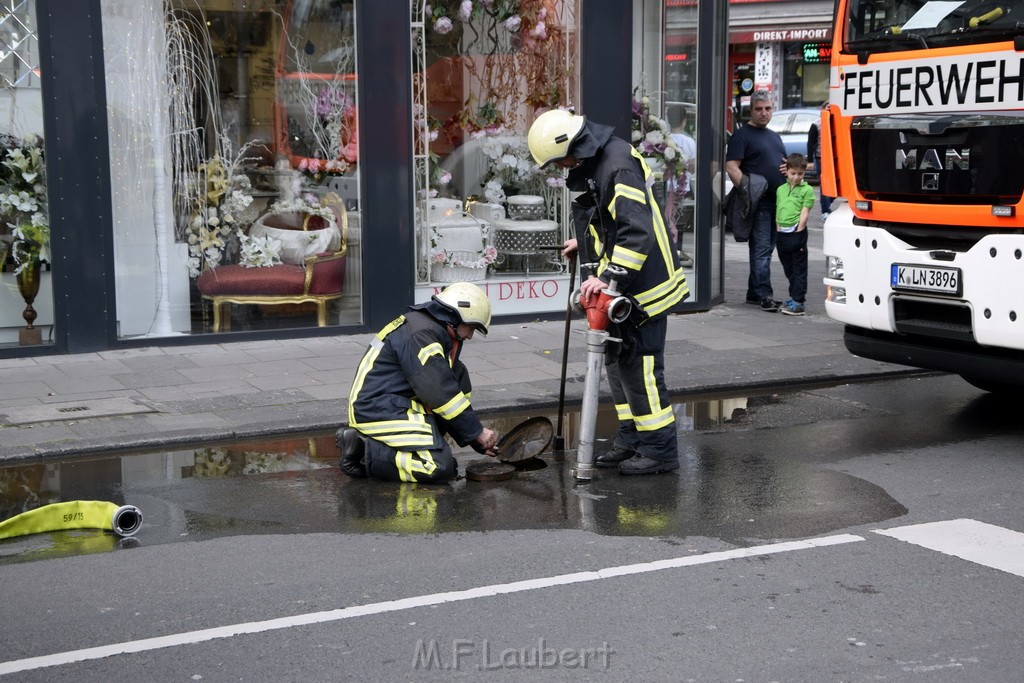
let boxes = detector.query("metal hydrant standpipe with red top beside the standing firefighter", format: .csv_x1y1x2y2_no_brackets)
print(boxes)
572,263,633,481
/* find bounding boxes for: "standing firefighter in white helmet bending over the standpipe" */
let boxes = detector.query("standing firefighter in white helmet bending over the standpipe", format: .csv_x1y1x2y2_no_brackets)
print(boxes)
527,110,689,474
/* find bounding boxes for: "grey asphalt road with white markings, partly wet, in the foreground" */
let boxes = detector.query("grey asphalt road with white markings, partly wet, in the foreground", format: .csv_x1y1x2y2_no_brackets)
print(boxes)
0,376,1024,682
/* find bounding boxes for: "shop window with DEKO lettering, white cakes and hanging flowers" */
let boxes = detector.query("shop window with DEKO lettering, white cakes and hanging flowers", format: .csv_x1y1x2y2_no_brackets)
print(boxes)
411,0,579,315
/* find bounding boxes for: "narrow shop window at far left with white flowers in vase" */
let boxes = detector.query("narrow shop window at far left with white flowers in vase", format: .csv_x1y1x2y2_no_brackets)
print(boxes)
0,0,53,347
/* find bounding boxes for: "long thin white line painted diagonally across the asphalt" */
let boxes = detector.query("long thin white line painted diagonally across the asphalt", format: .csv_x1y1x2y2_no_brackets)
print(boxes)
0,533,864,676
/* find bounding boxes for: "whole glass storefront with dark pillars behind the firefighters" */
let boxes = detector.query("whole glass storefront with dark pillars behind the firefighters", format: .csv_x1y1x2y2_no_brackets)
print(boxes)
0,0,725,357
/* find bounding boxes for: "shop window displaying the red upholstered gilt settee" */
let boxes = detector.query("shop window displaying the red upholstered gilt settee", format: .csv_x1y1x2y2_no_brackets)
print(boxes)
101,0,362,339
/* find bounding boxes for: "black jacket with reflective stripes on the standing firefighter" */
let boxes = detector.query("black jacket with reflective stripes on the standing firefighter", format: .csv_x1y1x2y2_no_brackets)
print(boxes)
566,121,689,317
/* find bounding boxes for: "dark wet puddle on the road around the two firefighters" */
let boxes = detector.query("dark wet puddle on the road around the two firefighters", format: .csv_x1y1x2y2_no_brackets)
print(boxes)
0,398,906,563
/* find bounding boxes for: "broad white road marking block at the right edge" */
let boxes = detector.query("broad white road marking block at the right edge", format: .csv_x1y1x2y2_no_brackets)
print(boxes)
873,519,1024,577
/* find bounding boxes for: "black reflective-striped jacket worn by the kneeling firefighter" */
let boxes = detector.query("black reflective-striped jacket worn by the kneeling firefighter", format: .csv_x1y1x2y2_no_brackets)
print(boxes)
348,301,483,451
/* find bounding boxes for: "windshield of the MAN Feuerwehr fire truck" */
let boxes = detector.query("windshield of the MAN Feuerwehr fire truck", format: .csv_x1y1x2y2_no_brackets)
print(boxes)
843,0,1024,52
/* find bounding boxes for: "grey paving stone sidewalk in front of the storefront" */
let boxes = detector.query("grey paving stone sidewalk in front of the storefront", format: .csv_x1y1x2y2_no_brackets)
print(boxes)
0,208,915,461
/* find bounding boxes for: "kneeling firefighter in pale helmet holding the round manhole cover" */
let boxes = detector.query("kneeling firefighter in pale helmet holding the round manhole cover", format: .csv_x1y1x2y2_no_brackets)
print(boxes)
338,283,498,483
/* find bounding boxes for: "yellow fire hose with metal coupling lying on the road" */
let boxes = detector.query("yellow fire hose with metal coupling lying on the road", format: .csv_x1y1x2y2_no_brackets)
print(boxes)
0,501,142,539
